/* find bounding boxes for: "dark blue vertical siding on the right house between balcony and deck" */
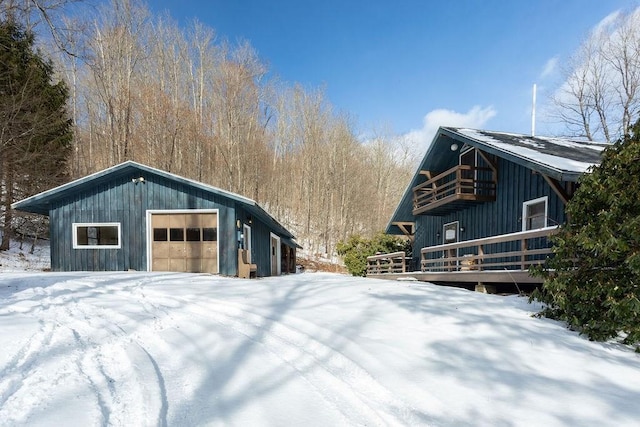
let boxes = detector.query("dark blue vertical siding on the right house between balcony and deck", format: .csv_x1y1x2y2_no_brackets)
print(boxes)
413,158,565,265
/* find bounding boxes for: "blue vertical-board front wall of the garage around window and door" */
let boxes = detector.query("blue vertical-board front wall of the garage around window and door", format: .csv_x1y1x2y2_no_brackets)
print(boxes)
50,174,237,275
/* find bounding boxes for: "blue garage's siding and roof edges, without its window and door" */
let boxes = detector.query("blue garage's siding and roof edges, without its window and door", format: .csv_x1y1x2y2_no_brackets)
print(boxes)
14,162,297,276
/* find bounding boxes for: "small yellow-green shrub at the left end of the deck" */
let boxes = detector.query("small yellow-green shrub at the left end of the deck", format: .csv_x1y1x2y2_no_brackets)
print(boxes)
337,233,411,276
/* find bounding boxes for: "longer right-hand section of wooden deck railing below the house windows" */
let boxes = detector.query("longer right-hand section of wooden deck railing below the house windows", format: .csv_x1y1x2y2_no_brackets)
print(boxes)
420,226,558,272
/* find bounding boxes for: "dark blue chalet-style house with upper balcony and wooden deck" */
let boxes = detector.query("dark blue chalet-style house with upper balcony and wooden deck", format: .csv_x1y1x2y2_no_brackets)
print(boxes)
369,127,606,290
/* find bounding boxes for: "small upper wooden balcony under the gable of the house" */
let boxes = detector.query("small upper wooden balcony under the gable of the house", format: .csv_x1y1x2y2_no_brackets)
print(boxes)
413,165,497,215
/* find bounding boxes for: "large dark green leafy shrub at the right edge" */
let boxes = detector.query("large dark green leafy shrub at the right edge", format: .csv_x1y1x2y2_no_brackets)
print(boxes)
532,120,640,350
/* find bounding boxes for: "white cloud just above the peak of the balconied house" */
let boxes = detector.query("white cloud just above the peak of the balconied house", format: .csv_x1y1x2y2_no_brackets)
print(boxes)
405,105,496,154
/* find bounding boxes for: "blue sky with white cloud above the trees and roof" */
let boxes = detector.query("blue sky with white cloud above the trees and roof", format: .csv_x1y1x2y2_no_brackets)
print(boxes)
149,0,640,147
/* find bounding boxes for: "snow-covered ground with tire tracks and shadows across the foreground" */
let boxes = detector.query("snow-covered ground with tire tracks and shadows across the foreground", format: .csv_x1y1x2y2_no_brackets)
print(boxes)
0,272,640,426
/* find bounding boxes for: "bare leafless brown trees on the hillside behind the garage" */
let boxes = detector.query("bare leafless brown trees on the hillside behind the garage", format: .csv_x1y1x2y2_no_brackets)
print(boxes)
47,0,415,255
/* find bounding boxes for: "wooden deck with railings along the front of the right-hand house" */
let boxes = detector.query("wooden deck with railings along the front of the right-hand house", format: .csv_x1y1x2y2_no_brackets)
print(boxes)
367,227,558,284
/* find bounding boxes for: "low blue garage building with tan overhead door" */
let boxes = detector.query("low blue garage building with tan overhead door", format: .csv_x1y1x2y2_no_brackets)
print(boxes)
13,161,299,276
